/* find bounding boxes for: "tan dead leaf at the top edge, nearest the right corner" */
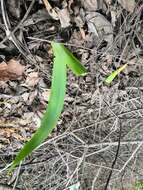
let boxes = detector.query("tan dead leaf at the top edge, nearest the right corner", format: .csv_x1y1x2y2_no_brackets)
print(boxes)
118,0,136,13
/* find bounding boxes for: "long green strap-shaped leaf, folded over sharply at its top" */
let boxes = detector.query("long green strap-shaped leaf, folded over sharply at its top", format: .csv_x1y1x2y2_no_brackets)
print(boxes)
11,42,86,170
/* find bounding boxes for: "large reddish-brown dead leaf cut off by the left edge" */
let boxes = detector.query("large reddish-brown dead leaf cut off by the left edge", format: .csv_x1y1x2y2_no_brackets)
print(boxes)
0,59,25,81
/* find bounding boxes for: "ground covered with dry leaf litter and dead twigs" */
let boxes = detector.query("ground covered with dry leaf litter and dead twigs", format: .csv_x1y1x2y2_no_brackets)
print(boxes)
0,0,143,190
